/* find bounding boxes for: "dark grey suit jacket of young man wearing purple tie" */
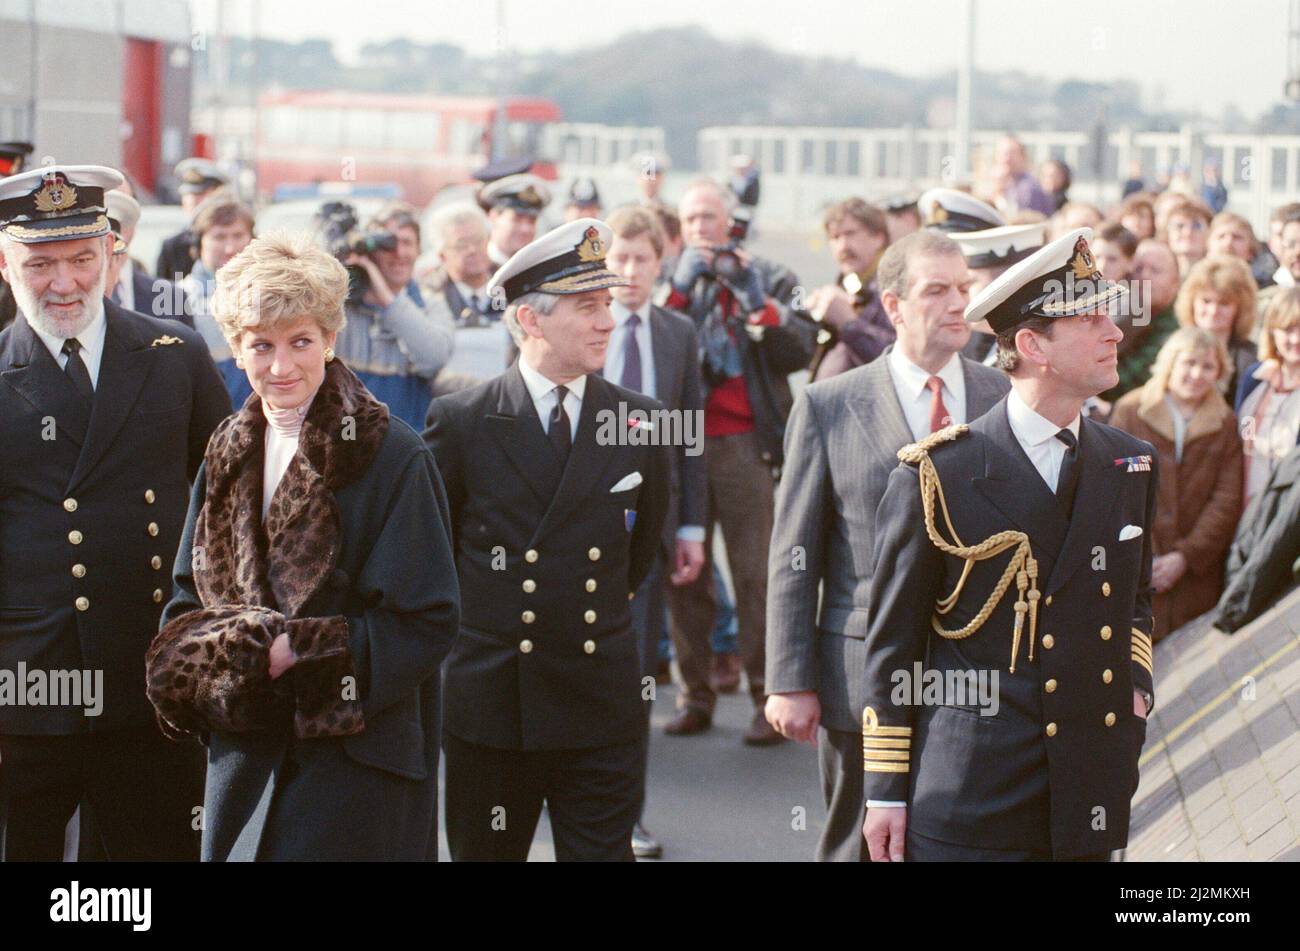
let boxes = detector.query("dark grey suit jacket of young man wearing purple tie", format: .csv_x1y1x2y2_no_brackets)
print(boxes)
644,304,709,545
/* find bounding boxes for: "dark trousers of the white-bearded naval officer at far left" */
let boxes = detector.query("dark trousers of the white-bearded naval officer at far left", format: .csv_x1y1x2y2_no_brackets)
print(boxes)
0,724,204,861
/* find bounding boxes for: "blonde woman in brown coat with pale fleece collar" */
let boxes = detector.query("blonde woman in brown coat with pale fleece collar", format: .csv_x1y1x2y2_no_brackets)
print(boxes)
1110,327,1242,640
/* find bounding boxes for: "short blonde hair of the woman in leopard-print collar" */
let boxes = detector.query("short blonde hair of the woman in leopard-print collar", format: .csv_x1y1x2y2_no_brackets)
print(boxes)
212,231,347,349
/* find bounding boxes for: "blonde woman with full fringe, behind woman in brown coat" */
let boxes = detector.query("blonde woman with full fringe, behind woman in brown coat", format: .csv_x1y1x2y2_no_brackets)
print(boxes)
1174,255,1258,400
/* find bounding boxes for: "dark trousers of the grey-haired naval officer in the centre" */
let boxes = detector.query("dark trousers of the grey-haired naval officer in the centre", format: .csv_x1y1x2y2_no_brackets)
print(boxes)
442,733,645,861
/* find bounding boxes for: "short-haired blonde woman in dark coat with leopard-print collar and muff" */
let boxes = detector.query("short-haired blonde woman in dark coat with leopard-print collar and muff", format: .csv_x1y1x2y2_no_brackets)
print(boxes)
147,235,459,861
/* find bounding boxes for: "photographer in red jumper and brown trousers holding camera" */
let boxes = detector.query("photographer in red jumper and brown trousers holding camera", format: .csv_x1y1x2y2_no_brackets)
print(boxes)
666,179,813,744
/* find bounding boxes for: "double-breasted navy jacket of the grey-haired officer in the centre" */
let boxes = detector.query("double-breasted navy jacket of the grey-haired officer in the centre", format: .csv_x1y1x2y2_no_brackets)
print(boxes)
425,365,668,750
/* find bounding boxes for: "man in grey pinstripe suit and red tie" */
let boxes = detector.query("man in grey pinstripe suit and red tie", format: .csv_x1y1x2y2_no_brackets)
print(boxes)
766,231,1010,861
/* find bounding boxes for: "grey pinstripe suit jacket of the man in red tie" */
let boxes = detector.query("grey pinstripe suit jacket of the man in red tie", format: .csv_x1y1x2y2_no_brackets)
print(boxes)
767,347,1010,733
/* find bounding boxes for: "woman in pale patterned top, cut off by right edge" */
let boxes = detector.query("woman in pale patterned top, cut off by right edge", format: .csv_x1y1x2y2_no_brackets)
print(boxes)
1236,287,1300,504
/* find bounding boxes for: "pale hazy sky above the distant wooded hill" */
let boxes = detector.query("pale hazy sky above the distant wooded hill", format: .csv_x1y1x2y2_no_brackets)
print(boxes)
192,0,1288,117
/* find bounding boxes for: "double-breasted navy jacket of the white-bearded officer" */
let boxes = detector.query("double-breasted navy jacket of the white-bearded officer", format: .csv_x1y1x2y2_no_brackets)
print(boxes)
0,300,230,735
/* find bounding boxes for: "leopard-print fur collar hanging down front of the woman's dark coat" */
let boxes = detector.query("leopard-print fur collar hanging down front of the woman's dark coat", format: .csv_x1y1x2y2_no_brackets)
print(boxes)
194,360,389,618
